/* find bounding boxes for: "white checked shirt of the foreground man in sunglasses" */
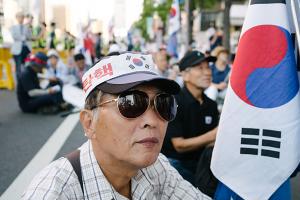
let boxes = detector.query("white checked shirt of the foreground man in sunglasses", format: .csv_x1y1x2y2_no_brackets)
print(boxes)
22,141,210,200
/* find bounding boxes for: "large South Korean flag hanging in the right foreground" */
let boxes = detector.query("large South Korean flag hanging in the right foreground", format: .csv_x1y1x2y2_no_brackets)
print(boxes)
211,0,300,200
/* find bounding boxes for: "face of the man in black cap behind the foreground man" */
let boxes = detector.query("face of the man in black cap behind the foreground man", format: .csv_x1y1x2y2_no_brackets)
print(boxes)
183,61,211,89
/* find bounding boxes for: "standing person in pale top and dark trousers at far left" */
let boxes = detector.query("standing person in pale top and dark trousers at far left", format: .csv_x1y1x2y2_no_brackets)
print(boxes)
10,12,32,78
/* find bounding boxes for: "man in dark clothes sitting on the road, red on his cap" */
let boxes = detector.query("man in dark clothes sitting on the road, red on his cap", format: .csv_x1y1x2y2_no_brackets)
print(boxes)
17,52,63,112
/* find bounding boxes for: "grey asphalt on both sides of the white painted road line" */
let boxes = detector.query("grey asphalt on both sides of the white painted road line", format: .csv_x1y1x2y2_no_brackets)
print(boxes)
0,90,85,200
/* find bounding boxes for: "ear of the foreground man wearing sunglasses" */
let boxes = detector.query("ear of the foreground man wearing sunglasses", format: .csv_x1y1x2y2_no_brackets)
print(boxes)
80,109,96,139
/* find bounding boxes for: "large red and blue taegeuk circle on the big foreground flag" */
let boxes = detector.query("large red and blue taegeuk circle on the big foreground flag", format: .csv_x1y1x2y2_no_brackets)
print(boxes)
230,25,299,108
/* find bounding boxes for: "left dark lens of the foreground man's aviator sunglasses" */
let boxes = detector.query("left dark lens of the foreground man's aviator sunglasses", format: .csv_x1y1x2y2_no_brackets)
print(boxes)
118,91,149,118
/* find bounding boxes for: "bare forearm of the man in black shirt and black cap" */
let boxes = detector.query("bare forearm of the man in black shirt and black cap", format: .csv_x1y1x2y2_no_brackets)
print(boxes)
171,128,217,153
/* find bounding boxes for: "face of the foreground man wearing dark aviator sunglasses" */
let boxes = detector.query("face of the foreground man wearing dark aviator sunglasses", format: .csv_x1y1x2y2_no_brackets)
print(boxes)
92,86,167,169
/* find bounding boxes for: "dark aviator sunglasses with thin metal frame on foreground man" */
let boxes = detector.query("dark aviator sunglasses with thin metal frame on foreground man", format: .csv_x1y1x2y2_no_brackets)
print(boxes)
94,90,177,122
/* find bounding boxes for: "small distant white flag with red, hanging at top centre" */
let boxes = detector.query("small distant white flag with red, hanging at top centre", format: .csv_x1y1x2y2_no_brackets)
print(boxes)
168,0,180,36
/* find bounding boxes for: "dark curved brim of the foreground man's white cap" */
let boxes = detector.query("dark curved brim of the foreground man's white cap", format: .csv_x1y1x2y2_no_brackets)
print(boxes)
98,73,180,94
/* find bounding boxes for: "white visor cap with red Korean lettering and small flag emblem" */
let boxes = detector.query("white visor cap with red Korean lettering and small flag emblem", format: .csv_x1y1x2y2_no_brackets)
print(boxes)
82,52,180,99
